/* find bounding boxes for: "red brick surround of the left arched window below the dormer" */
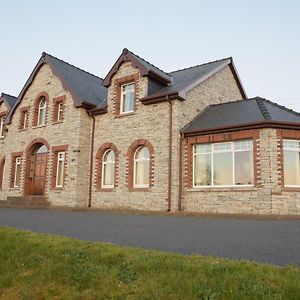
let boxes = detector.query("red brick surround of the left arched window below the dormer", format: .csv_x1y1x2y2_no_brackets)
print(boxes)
95,143,120,190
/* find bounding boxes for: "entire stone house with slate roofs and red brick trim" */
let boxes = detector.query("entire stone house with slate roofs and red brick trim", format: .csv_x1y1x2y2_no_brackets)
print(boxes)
0,49,300,215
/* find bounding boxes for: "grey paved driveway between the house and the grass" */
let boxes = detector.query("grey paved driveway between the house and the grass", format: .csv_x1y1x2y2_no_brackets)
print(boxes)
0,208,300,266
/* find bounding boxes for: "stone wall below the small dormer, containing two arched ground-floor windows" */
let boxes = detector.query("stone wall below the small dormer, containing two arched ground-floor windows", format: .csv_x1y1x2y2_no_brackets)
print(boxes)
92,62,169,211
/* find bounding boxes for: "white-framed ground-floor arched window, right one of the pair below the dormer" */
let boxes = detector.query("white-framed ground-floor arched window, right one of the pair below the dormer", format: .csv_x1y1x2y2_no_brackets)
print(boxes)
133,146,150,188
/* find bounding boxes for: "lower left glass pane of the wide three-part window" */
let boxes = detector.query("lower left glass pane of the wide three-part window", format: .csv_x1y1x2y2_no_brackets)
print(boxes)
194,154,211,186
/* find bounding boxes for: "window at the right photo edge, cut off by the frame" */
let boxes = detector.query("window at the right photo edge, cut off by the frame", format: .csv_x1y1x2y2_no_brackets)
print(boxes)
283,140,300,187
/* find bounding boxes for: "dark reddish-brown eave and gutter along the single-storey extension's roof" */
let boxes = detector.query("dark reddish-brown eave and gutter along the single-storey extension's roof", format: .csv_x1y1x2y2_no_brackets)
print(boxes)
181,120,300,137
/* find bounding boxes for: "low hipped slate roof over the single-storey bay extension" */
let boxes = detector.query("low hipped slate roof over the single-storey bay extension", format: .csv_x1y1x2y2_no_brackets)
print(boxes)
181,97,300,133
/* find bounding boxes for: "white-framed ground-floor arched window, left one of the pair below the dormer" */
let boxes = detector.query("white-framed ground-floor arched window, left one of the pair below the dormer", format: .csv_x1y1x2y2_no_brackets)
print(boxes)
102,149,115,188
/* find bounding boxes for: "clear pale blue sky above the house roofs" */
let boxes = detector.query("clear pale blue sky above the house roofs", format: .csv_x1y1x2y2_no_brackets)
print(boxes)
0,0,300,111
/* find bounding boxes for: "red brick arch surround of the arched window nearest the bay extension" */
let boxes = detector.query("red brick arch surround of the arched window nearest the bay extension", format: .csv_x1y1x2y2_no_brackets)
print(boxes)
126,139,154,190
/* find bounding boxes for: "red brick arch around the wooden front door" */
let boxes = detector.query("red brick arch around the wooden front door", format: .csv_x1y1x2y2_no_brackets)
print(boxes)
24,138,50,195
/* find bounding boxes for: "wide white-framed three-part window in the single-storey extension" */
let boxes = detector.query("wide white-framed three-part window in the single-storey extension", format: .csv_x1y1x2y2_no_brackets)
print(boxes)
193,140,254,187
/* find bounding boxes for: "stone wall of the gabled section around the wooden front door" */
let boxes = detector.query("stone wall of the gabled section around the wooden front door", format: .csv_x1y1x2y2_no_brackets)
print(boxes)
0,64,91,206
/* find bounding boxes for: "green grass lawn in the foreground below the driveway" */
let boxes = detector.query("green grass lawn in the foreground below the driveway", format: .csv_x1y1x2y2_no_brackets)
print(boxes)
0,227,300,300
